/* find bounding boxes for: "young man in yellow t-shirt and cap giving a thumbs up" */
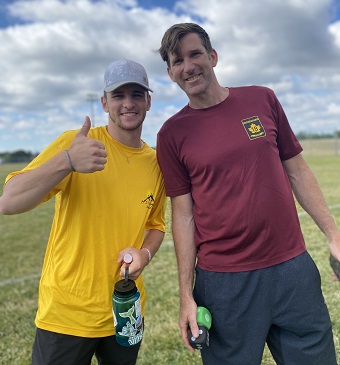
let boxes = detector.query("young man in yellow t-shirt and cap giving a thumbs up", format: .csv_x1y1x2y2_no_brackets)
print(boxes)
0,60,165,365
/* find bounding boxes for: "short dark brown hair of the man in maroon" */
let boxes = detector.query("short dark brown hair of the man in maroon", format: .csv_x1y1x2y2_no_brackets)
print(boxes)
158,23,212,67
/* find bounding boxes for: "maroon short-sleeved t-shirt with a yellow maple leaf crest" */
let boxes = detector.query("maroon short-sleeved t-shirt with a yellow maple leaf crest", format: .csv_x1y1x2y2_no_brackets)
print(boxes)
157,86,306,272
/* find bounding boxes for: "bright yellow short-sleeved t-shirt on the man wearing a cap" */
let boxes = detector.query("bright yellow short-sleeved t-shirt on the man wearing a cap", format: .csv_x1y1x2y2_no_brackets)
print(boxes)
7,127,165,337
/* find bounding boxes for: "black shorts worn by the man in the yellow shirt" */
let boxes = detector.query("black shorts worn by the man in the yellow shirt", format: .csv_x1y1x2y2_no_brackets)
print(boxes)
32,328,141,365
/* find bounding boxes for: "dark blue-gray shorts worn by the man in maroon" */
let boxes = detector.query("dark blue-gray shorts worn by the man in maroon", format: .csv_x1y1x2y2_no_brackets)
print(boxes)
194,252,337,365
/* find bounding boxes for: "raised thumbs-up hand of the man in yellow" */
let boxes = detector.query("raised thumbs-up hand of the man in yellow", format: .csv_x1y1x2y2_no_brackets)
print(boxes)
68,116,107,173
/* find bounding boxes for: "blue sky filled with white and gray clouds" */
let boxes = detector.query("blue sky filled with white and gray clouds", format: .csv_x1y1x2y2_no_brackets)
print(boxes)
0,0,340,152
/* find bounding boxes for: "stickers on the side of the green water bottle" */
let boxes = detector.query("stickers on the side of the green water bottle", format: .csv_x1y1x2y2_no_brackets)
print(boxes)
114,298,143,346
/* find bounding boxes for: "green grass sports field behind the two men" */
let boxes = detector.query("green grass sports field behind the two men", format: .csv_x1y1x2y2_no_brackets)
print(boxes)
0,139,340,365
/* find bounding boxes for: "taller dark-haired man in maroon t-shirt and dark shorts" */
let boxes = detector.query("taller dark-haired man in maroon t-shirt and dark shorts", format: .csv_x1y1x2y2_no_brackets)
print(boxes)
157,23,340,365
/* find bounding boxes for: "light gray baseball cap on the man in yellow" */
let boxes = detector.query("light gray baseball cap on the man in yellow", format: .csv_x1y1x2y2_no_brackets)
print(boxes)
104,59,152,92
